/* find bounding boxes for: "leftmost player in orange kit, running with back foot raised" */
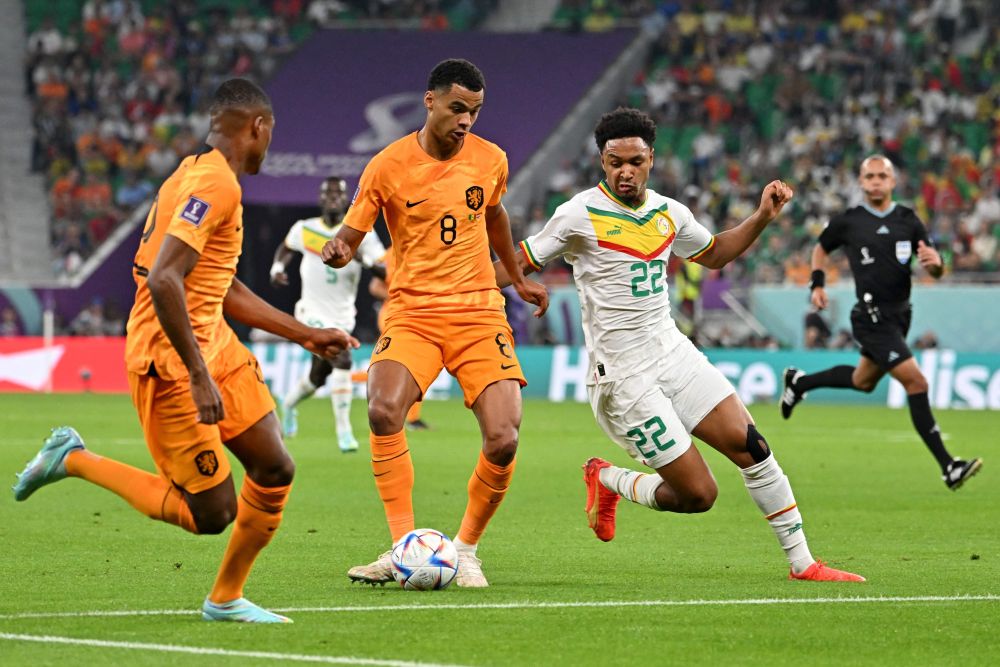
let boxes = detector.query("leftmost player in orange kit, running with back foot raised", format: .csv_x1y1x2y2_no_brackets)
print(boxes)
14,79,357,623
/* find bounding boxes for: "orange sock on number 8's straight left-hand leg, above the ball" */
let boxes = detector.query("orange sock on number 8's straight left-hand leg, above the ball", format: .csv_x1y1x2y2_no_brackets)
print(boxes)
369,434,419,542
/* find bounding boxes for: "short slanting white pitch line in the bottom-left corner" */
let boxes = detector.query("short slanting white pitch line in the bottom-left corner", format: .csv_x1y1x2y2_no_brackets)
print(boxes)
0,632,468,667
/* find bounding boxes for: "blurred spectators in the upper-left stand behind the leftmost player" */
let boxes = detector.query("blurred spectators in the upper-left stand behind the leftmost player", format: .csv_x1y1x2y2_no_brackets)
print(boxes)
25,0,320,275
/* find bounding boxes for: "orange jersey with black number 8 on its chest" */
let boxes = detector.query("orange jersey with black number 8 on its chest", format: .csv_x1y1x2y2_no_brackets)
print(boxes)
344,132,507,319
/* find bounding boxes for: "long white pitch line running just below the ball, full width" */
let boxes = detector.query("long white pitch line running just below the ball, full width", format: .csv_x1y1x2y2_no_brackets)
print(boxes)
0,593,1000,620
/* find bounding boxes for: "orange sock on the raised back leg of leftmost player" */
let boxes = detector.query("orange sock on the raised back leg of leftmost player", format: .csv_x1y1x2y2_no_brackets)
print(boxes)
66,450,198,533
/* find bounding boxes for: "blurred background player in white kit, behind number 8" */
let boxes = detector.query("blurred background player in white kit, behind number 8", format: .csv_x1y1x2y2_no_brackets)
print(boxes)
271,176,385,452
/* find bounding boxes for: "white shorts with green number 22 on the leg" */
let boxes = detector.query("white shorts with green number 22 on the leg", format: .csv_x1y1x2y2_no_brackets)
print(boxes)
588,339,736,469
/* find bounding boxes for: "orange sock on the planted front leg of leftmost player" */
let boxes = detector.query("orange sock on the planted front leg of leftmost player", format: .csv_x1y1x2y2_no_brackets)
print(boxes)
208,476,292,604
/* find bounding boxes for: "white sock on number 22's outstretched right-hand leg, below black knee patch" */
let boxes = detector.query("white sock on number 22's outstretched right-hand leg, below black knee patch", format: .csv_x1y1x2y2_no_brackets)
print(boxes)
740,454,815,574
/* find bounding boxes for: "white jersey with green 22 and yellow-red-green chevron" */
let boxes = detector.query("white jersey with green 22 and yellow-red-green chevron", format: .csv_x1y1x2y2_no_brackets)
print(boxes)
521,181,715,382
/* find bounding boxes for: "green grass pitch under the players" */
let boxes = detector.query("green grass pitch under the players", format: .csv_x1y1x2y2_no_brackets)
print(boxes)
0,395,1000,666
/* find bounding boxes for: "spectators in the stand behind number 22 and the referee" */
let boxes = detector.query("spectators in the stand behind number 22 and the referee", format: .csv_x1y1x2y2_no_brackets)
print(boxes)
540,0,1000,285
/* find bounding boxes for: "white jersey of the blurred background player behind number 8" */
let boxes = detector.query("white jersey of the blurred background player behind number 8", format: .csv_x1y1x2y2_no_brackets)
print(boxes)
285,218,385,332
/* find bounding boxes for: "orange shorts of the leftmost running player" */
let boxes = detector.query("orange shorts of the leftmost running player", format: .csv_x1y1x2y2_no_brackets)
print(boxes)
128,341,274,493
